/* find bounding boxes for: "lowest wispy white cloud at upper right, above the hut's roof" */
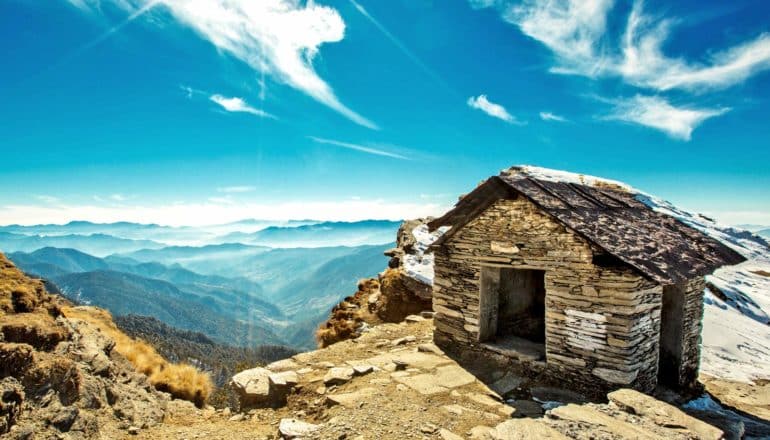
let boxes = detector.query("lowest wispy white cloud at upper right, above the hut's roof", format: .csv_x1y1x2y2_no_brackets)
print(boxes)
606,95,730,141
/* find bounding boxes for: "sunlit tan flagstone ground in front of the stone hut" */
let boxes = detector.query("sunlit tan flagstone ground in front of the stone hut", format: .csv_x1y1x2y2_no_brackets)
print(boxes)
139,317,770,440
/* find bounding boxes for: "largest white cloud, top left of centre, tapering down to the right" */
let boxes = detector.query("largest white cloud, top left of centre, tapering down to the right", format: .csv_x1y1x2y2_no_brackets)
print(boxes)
70,0,378,129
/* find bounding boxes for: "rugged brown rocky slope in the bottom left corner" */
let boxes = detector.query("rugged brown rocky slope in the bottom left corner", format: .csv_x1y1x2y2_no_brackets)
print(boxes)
0,255,176,438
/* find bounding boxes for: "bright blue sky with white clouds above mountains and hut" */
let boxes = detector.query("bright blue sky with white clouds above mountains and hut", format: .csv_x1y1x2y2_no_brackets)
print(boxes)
0,0,770,224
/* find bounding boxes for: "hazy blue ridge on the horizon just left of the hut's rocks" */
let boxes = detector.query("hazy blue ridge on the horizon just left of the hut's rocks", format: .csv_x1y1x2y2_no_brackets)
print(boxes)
214,220,401,247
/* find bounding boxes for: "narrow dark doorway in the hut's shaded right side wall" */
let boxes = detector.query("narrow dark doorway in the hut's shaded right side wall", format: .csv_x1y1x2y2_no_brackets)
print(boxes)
658,285,684,387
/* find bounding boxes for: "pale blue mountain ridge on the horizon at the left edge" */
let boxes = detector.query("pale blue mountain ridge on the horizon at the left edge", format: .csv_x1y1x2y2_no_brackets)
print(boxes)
0,231,164,256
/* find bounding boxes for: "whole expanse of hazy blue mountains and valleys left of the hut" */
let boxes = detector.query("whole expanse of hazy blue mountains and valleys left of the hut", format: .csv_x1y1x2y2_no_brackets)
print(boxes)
0,220,399,348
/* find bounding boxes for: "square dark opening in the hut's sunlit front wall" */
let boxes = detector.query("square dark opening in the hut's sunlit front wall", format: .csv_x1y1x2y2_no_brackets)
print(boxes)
479,267,545,343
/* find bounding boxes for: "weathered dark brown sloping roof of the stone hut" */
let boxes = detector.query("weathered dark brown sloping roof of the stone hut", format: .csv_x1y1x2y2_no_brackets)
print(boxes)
429,169,745,284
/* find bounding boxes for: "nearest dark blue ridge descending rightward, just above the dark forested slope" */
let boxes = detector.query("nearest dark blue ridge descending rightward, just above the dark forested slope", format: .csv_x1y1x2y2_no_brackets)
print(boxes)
52,270,282,346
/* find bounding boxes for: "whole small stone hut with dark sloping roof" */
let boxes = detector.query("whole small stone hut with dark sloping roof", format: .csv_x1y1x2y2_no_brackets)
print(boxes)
429,167,745,392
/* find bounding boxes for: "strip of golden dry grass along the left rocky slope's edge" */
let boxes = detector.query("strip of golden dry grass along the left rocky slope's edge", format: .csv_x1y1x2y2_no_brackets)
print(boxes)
62,307,213,407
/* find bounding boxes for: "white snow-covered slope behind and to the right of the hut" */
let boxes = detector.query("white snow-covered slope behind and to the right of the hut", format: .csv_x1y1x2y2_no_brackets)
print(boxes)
462,165,770,382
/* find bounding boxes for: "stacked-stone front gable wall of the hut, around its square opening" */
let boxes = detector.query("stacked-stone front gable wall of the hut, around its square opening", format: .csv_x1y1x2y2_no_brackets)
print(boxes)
433,197,664,391
